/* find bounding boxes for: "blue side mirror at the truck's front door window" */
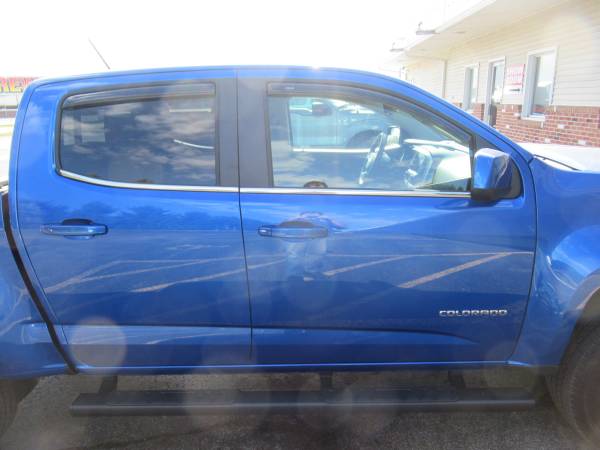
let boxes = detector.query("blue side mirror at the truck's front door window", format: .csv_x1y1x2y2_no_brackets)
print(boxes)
471,148,514,202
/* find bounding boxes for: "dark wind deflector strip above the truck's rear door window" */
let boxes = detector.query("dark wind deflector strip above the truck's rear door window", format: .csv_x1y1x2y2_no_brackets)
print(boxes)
63,83,215,108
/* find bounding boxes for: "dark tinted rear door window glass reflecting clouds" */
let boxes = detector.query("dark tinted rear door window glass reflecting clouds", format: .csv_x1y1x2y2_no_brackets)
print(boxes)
59,96,217,186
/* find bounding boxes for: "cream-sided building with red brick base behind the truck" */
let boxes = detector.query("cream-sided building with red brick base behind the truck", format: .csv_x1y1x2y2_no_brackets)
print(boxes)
396,0,600,146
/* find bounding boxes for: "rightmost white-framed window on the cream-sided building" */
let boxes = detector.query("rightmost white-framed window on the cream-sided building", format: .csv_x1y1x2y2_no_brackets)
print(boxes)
523,50,556,118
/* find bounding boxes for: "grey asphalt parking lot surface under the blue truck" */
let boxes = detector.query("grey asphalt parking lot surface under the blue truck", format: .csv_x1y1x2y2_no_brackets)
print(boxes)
0,374,592,450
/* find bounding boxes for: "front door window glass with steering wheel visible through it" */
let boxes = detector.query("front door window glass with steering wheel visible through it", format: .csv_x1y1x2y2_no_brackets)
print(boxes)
269,96,471,192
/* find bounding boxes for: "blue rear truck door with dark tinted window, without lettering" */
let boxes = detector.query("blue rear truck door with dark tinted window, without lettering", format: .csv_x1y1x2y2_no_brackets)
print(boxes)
11,70,250,370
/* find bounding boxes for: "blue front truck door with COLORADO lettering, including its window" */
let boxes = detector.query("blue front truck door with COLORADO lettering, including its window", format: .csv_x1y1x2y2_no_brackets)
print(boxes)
238,73,535,364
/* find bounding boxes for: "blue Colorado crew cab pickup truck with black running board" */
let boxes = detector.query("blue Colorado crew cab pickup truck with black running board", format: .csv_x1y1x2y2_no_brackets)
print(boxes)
0,67,600,441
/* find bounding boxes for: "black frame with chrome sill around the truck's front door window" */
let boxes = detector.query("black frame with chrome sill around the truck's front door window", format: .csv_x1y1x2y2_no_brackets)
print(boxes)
264,80,477,198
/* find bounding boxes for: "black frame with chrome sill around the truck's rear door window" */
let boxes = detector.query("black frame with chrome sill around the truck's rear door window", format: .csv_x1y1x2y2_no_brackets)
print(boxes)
52,79,238,192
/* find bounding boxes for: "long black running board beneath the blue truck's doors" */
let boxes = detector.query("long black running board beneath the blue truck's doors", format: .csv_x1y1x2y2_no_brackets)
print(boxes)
70,387,536,416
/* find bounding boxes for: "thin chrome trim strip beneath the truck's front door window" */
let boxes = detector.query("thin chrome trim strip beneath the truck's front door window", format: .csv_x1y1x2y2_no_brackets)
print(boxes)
240,187,471,198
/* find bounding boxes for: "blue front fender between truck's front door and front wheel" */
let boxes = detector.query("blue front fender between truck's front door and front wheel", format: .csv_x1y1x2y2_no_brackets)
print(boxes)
510,160,600,366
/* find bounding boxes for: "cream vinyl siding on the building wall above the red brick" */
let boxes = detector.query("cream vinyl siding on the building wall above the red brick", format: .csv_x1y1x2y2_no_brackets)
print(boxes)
445,0,600,106
